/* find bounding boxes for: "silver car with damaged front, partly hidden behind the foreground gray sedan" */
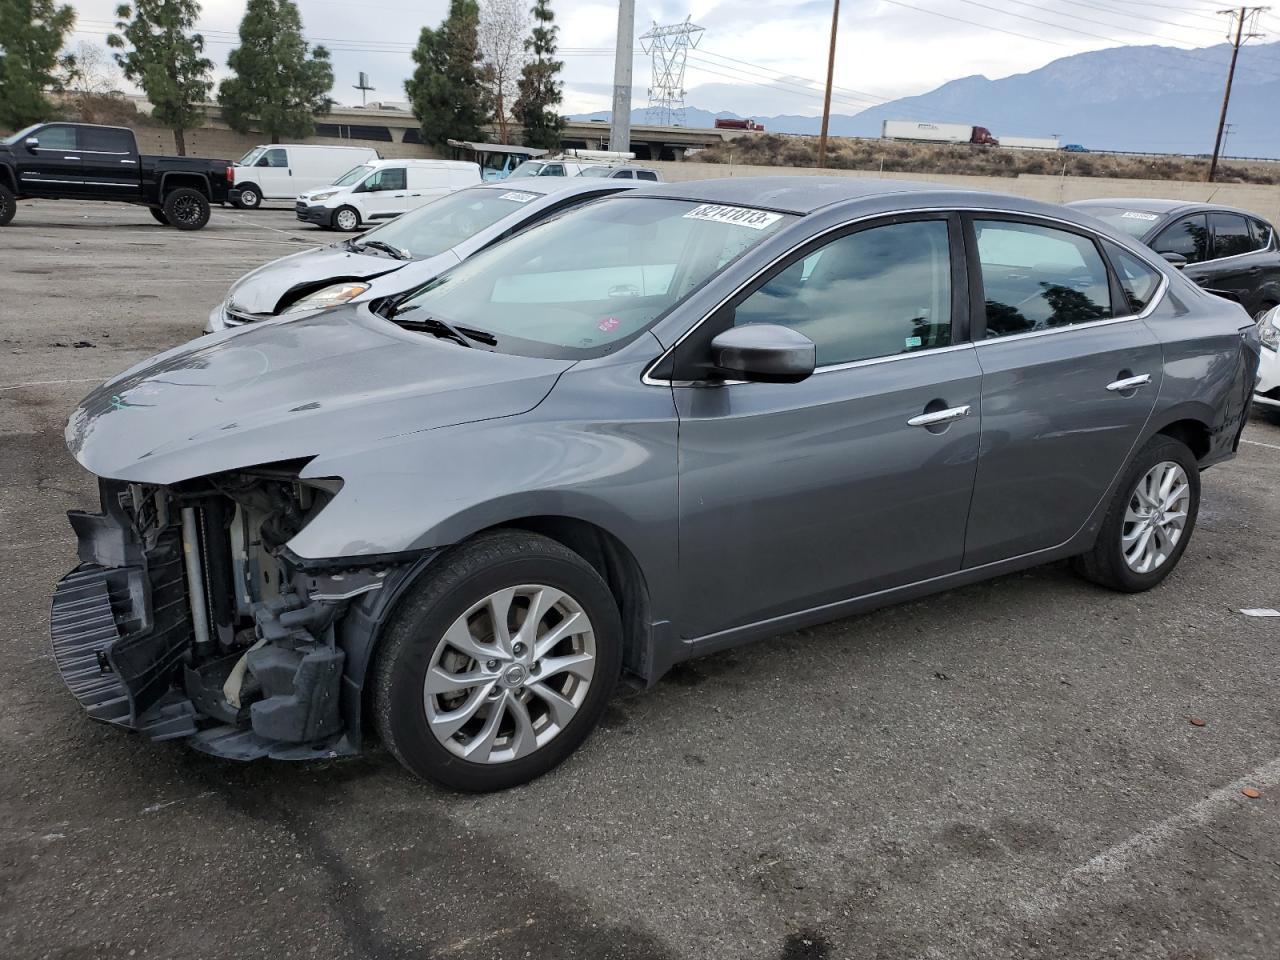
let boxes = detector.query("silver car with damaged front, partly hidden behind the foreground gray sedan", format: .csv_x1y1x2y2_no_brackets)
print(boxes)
205,178,635,333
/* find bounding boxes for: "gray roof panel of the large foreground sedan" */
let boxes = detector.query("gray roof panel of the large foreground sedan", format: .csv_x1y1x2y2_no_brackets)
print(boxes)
636,177,977,215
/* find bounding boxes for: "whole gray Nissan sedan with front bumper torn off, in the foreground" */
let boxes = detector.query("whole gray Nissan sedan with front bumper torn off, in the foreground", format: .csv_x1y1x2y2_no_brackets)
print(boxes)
52,178,1258,790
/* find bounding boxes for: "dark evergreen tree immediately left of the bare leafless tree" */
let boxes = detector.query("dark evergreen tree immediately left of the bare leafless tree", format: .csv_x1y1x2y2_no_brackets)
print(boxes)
404,0,489,147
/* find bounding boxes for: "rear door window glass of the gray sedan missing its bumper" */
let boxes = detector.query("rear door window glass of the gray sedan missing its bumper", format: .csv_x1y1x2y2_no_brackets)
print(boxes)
974,220,1111,339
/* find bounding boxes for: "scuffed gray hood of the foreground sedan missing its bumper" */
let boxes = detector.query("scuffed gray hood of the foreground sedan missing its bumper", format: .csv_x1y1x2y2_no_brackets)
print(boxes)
67,307,573,484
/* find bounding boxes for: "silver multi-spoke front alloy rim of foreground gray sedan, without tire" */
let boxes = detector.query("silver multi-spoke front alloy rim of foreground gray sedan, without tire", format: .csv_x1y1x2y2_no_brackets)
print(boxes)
422,584,596,763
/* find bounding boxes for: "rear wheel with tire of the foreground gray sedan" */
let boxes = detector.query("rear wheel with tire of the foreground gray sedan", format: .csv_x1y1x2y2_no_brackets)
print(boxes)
1074,434,1201,593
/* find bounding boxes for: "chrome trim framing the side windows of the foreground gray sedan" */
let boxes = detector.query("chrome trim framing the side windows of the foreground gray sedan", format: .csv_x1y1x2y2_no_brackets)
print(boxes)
640,206,1172,387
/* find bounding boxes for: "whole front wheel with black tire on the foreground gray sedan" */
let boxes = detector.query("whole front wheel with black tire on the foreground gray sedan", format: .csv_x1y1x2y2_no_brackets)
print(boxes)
371,530,622,792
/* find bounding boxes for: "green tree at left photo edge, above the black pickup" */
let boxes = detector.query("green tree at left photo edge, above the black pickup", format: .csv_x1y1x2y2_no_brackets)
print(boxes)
0,0,76,129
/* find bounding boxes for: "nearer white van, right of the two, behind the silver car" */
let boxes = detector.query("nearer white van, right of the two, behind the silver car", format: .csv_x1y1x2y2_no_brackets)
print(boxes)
294,160,480,230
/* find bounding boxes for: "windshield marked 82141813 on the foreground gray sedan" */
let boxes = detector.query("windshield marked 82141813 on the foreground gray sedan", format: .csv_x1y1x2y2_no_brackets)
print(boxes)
393,197,794,360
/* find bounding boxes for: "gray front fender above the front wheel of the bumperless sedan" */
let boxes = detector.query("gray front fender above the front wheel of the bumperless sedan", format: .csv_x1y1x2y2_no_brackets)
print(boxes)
289,364,678,617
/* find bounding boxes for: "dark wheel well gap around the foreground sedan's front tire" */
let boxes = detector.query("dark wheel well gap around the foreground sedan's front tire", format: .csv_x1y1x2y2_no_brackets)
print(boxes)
477,516,650,676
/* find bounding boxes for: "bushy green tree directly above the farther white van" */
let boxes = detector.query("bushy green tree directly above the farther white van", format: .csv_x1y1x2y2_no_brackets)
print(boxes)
218,0,333,143
